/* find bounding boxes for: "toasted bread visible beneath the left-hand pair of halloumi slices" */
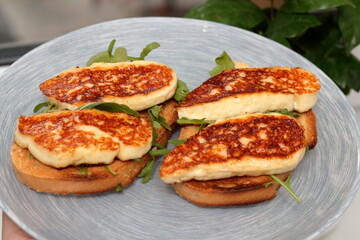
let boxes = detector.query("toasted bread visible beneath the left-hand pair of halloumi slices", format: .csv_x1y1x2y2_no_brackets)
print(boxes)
11,100,177,194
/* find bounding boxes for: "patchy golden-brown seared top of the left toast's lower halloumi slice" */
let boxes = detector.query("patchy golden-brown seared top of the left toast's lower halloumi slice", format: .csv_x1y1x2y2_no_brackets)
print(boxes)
18,109,151,154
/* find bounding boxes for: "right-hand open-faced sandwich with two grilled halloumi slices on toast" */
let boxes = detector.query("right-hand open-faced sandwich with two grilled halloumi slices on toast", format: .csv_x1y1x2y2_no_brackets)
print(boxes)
160,54,320,206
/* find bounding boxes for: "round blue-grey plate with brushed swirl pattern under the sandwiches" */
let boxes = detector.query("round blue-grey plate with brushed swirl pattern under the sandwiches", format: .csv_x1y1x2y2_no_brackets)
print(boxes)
0,18,360,239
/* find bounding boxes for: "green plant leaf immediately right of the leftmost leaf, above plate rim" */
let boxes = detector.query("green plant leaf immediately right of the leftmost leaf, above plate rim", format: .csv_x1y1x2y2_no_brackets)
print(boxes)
265,11,321,47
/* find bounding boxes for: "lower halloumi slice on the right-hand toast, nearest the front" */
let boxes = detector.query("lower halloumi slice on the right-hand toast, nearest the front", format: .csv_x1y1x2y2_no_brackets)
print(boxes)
160,113,306,184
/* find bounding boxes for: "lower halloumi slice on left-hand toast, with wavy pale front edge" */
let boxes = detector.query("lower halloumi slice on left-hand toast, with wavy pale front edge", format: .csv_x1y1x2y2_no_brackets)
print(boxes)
14,109,152,168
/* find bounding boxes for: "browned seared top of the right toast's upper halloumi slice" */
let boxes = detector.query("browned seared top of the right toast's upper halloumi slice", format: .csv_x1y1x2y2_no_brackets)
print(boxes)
179,67,320,107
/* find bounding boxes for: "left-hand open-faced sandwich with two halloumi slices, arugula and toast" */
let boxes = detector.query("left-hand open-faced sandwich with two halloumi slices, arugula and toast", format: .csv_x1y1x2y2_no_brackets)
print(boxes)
11,42,183,194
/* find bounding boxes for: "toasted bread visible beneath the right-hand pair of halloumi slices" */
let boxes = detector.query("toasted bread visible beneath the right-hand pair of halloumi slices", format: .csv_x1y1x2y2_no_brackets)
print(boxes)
166,110,317,206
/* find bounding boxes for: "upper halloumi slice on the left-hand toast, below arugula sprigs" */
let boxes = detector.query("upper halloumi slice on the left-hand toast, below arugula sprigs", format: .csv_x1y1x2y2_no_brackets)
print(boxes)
40,61,177,111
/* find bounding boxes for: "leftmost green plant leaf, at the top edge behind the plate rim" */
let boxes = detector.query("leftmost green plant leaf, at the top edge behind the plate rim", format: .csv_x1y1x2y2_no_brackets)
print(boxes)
185,0,266,29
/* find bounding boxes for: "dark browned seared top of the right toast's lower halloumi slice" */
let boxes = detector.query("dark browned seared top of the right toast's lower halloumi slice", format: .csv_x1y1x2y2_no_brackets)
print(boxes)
160,115,305,176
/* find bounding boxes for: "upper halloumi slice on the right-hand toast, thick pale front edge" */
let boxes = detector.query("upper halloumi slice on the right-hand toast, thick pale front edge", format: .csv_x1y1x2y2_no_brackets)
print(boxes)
178,67,320,120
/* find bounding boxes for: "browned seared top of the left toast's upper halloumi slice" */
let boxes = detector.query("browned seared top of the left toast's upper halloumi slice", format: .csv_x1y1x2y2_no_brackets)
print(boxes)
40,64,173,104
